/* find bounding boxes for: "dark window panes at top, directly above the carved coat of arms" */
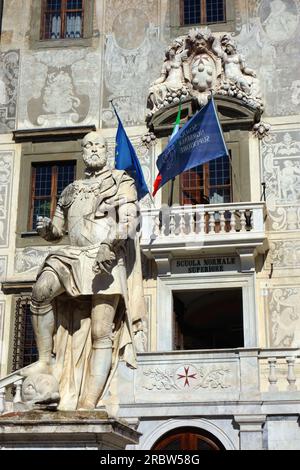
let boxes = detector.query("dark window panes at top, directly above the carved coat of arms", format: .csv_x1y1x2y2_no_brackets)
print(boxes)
181,0,226,25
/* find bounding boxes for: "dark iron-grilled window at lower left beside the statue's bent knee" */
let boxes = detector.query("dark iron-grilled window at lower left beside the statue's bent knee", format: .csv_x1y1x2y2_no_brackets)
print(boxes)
13,297,38,371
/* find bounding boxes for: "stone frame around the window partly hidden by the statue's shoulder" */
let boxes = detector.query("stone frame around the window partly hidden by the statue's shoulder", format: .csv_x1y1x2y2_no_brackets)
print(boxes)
16,139,84,248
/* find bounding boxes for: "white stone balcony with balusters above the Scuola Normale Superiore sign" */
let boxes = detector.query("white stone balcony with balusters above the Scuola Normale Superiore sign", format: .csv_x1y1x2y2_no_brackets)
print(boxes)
141,202,267,258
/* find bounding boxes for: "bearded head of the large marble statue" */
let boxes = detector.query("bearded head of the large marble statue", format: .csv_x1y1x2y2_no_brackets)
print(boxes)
82,132,107,171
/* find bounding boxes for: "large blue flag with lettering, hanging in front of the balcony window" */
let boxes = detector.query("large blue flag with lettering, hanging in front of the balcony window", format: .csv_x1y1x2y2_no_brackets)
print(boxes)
156,98,228,193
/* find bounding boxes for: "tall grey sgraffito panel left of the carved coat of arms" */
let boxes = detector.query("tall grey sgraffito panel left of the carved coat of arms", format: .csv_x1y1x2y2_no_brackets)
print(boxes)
101,0,165,127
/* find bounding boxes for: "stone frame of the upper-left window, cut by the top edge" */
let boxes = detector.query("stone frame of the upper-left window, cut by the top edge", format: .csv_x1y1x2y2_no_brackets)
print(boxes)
29,0,95,49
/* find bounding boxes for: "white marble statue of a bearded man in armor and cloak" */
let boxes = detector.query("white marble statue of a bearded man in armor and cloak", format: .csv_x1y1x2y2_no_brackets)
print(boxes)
25,132,144,409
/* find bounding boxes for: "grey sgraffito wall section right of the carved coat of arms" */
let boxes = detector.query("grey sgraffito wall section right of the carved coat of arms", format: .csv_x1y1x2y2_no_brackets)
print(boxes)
236,0,300,116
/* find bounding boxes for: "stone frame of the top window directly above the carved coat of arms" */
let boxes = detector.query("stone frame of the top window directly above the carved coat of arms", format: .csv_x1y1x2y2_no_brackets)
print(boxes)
170,0,235,37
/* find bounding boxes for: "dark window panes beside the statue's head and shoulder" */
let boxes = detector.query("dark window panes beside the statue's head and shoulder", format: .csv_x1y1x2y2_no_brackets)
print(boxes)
28,161,76,230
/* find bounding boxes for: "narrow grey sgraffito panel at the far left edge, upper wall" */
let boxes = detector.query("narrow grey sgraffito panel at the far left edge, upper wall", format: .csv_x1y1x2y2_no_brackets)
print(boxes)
0,50,20,133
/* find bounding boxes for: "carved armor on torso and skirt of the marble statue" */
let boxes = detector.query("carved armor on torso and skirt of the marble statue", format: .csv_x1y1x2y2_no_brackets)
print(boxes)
41,169,136,296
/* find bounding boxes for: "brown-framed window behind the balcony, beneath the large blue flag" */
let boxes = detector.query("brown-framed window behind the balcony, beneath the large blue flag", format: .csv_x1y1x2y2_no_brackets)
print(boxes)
180,157,231,204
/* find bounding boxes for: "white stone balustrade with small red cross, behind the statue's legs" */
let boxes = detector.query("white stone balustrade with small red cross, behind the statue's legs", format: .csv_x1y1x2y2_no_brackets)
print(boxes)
0,348,300,414
